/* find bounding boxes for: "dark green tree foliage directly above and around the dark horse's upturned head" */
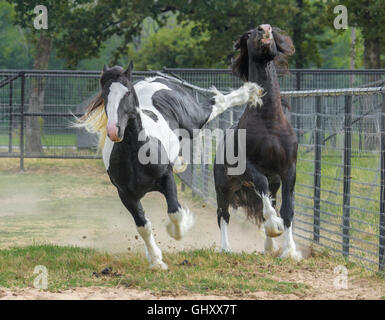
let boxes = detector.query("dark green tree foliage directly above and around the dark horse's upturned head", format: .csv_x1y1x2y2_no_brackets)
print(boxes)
164,0,331,68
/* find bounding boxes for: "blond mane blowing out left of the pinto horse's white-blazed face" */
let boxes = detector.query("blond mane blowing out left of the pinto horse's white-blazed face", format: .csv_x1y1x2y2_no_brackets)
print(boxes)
73,93,107,151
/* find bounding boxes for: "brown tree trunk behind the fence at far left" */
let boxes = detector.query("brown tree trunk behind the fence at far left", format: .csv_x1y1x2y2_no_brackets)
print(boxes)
25,33,52,153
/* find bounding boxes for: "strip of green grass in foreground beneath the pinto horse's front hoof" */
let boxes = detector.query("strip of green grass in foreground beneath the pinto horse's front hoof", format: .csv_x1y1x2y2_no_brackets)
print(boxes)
0,245,332,294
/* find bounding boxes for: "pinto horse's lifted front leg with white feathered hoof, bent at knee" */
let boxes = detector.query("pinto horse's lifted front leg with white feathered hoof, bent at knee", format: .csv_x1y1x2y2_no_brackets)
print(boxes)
160,171,194,240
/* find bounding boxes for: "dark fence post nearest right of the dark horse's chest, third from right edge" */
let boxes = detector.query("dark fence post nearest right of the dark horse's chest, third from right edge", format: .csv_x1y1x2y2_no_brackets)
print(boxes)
313,96,322,242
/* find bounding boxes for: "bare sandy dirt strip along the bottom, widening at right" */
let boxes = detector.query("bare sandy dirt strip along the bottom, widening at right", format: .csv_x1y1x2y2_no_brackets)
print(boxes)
0,270,385,300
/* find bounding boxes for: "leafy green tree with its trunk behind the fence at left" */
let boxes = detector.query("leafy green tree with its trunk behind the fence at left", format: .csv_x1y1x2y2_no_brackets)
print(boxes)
7,0,171,152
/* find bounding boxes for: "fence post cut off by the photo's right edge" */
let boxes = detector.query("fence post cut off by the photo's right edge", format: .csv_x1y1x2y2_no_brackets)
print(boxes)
378,94,385,271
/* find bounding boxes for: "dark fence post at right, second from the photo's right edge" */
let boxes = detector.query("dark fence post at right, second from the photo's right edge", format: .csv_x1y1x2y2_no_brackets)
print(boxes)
342,96,352,256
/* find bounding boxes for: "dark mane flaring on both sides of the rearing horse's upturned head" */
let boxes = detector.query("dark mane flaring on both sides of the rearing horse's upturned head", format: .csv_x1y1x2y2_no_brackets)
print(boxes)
231,27,295,81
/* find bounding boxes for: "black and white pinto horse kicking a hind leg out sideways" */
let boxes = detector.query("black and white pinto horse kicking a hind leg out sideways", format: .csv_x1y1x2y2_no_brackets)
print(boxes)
78,62,261,269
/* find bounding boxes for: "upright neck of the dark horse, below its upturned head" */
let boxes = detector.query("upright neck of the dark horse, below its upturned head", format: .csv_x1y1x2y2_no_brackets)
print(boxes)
248,59,283,116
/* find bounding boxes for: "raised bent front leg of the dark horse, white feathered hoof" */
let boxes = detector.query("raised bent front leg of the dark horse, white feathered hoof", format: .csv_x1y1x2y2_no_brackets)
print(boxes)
245,161,284,238
